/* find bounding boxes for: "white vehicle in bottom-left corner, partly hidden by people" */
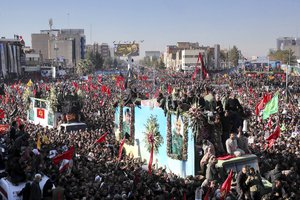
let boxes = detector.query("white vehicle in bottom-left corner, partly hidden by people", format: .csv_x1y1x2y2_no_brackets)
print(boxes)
0,175,49,200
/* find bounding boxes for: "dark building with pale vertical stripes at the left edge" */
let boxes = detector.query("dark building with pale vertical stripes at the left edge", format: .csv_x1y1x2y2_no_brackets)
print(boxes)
0,38,24,78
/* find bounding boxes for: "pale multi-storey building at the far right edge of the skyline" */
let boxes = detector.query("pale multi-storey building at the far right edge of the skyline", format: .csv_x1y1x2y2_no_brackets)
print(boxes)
277,37,300,59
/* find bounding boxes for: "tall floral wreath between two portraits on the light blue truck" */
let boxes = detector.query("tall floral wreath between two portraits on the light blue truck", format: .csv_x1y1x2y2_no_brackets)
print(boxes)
144,115,164,153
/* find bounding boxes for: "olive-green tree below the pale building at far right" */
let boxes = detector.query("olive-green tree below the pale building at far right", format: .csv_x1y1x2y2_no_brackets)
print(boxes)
269,49,297,65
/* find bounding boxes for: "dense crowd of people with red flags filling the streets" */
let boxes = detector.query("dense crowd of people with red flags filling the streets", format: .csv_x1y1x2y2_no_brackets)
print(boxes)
0,67,300,200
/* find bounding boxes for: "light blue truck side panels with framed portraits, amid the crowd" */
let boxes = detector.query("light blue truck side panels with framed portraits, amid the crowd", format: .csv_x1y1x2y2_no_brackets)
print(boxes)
115,100,195,177
